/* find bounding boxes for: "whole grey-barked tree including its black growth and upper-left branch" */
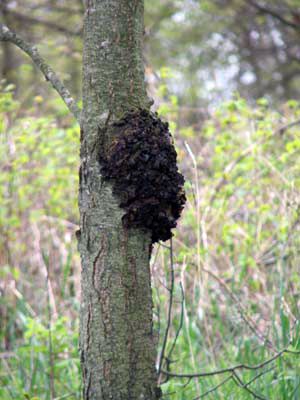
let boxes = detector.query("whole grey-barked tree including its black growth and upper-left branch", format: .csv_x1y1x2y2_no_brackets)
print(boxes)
0,0,185,400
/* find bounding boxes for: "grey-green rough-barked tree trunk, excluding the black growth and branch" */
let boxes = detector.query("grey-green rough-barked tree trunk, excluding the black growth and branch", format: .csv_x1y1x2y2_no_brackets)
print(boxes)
78,0,159,400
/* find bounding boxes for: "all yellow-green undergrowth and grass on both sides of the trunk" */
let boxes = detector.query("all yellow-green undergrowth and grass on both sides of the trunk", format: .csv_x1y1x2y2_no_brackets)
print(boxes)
0,86,300,400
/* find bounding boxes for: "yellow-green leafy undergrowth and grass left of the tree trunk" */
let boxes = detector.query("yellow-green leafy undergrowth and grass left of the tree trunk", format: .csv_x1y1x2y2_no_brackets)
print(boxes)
0,86,80,400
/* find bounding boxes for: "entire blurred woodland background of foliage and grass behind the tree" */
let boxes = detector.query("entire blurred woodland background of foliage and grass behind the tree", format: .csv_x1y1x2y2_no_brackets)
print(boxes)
0,0,300,400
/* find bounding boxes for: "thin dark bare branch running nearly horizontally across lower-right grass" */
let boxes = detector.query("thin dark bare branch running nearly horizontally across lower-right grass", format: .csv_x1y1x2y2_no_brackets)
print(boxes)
161,348,300,378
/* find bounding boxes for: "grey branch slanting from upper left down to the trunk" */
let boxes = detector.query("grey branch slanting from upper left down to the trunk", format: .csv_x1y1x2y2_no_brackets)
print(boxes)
0,24,81,123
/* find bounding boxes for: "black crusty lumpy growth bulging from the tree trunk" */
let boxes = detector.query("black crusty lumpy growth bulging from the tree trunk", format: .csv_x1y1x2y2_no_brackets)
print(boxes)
100,110,186,243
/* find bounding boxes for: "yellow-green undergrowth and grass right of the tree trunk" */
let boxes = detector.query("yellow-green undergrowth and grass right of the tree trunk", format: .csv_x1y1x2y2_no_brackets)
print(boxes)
157,91,300,400
